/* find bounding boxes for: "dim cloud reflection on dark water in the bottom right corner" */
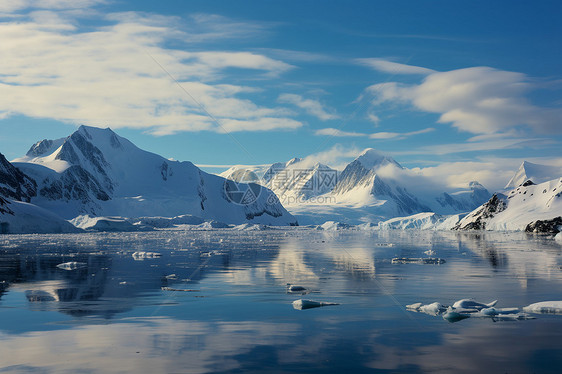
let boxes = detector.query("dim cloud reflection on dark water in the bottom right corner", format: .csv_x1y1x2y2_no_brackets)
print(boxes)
360,321,562,374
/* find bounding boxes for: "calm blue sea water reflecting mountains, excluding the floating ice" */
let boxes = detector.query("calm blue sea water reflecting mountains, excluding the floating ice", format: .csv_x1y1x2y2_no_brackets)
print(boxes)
0,228,562,373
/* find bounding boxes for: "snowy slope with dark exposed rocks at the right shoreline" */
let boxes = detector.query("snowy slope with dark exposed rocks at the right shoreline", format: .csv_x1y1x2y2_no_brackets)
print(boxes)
455,178,562,230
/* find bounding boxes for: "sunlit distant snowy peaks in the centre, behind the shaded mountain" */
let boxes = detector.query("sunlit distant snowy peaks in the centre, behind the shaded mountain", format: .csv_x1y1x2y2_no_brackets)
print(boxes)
221,149,491,224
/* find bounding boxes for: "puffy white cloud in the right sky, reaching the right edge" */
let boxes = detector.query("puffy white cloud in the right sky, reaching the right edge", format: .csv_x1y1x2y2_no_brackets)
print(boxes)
367,67,562,134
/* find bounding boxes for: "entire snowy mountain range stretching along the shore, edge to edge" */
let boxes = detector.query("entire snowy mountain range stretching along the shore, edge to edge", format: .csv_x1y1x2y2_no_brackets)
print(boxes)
0,126,562,233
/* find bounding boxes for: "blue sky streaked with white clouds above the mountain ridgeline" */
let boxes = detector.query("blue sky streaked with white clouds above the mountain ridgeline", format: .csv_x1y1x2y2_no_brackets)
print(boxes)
0,0,562,189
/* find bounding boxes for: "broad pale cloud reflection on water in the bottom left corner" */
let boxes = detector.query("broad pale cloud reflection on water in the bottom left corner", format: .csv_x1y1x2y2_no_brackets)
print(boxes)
0,318,298,373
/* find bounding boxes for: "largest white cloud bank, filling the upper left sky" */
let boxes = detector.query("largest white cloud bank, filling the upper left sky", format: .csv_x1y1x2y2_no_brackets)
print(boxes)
0,6,302,135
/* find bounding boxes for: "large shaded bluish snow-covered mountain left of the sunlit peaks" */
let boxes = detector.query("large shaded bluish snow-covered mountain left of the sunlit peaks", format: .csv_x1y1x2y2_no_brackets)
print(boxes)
14,126,296,225
